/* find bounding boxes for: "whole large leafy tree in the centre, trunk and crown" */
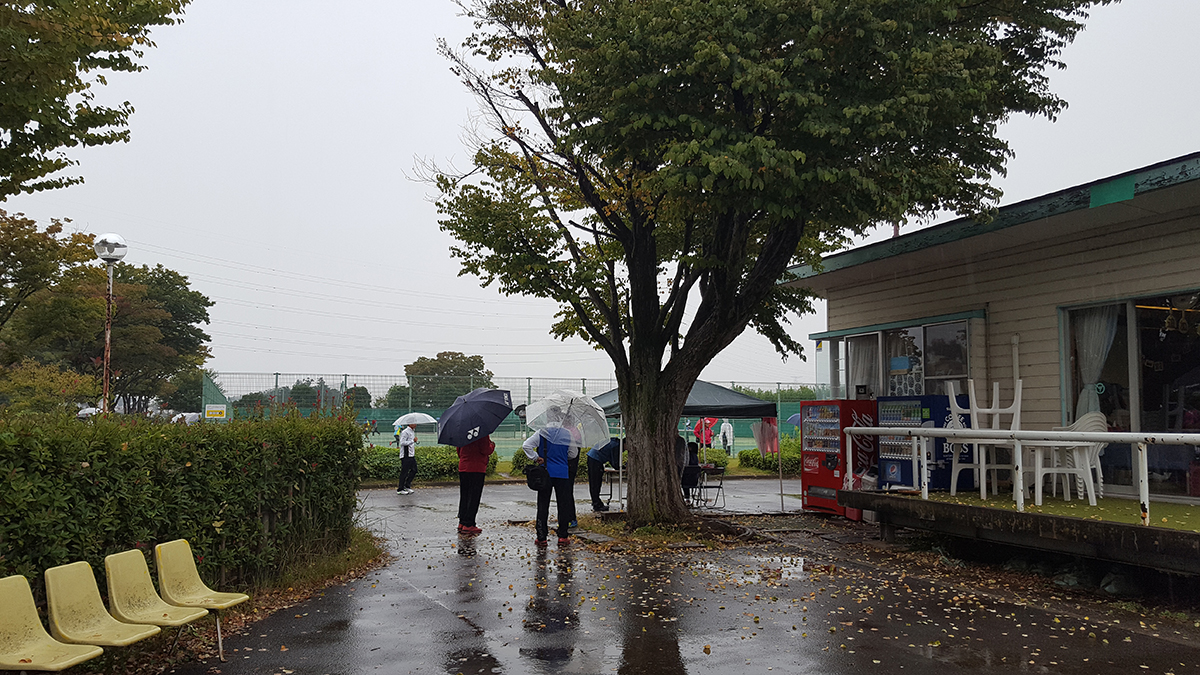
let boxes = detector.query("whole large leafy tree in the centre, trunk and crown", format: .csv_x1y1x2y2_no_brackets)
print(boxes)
434,0,1108,522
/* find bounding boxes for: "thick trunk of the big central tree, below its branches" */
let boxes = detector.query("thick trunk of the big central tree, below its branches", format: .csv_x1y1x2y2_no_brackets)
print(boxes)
618,369,692,526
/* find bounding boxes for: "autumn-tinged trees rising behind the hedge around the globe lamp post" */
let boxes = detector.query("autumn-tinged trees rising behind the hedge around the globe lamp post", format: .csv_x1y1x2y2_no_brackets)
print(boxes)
0,210,212,412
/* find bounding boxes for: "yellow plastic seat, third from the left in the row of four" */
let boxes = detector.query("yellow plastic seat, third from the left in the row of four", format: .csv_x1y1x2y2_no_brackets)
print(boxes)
104,549,209,626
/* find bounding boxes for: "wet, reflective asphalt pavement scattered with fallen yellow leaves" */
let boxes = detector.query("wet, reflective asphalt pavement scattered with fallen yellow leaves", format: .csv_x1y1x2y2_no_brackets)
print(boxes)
166,480,1200,675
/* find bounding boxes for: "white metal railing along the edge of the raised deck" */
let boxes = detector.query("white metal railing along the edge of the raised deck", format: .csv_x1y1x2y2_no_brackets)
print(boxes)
842,426,1200,525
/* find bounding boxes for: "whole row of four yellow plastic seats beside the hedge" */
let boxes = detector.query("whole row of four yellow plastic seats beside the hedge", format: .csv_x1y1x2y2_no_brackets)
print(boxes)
0,539,250,670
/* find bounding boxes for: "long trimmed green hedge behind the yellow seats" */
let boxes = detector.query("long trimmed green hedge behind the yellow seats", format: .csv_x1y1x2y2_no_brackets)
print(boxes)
0,413,361,593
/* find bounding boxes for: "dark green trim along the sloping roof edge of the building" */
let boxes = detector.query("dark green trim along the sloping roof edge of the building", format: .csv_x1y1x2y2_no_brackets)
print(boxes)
780,153,1200,283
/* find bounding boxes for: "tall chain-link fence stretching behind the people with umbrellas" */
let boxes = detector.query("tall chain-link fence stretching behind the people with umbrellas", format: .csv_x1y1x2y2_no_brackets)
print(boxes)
199,372,829,458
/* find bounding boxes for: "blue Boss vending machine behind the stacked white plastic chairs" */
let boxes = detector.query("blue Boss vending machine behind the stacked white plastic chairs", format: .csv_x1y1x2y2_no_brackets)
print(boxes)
876,396,976,491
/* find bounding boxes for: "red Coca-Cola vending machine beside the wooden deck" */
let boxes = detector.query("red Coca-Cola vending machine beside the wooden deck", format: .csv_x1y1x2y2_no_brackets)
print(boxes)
800,400,878,520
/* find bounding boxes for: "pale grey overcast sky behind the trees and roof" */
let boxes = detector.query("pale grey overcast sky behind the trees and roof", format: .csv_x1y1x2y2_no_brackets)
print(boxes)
0,0,1200,382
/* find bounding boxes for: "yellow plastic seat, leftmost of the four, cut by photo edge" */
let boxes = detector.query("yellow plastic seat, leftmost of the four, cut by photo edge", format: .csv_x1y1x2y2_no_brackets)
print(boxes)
0,574,104,670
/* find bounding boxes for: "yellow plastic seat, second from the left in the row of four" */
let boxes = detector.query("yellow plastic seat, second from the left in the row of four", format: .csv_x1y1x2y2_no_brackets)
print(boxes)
46,561,162,647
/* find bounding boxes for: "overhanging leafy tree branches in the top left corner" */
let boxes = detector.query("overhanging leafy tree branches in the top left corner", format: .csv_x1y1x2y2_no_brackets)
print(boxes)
0,0,188,196
